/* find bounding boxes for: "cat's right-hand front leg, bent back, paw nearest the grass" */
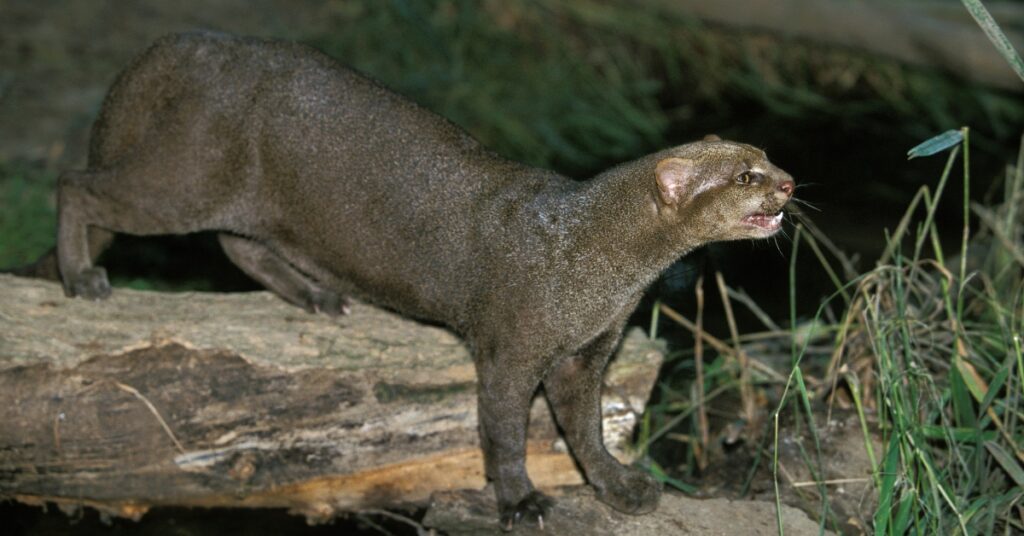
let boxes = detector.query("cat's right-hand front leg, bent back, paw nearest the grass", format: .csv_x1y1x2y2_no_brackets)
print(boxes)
544,329,662,514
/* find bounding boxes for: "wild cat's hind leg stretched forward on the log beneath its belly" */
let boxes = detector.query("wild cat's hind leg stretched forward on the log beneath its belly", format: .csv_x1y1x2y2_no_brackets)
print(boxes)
217,233,348,316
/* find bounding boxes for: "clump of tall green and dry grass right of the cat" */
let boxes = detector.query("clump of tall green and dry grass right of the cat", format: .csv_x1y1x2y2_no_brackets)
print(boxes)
778,129,1024,535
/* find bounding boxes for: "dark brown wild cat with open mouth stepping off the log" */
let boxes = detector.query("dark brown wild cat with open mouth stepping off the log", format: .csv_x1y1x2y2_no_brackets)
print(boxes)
51,34,793,527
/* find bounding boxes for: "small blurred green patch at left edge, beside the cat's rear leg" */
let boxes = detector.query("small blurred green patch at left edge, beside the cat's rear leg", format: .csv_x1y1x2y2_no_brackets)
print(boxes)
0,166,56,267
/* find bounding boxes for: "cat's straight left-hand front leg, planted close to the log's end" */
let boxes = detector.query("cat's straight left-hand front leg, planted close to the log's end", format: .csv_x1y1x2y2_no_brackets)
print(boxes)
476,353,553,531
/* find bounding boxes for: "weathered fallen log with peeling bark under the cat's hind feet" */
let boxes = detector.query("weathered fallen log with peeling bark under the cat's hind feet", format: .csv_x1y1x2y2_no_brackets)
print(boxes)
0,276,663,521
